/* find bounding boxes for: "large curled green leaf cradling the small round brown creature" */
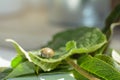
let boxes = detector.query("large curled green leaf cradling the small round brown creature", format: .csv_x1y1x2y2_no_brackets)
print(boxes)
7,27,107,71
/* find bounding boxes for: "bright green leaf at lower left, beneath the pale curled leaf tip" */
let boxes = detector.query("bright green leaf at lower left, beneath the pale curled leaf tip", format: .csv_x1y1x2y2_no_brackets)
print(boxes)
5,61,35,78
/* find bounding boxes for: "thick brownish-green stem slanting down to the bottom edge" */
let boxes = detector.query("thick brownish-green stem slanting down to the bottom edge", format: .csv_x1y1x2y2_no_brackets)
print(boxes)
66,58,100,80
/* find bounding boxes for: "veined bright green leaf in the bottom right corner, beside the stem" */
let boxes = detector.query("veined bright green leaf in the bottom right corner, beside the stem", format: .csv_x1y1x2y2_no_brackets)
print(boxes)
78,56,120,80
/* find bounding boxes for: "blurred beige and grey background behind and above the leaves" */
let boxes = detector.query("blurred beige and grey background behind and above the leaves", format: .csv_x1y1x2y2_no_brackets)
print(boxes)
0,0,119,66
